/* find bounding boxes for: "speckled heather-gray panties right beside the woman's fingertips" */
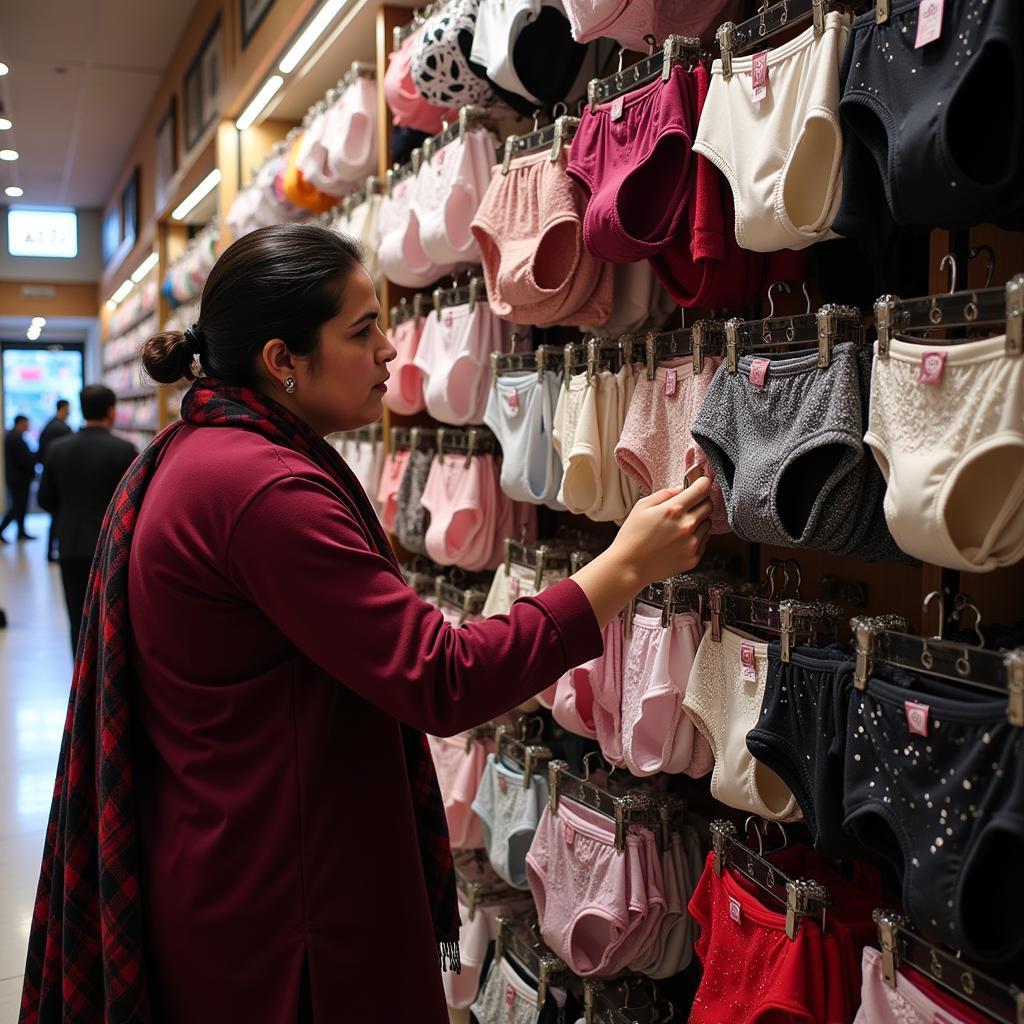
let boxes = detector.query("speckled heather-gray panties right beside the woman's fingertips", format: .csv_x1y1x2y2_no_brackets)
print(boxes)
692,343,899,558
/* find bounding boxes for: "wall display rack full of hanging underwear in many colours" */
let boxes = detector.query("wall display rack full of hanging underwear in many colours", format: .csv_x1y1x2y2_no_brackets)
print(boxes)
222,0,1024,1011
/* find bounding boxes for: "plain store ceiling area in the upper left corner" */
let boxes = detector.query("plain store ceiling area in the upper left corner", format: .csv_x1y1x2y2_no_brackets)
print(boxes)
0,0,193,207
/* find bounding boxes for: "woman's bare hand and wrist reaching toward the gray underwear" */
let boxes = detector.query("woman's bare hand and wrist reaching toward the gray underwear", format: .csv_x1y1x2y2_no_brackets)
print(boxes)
572,476,712,629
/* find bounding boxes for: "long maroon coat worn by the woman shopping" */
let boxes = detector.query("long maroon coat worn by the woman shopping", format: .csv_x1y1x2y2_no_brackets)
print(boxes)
128,426,601,1024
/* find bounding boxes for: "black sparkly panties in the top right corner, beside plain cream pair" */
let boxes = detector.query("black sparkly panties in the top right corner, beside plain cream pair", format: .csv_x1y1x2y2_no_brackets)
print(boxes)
836,0,1024,238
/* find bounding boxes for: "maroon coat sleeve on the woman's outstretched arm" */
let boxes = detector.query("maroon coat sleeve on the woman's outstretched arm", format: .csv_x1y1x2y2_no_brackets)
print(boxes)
226,475,602,736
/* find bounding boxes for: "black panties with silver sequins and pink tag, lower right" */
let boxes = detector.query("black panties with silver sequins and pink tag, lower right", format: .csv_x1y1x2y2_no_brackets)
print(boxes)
843,669,1024,964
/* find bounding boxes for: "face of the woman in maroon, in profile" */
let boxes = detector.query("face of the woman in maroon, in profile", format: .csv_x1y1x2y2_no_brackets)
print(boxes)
290,267,398,434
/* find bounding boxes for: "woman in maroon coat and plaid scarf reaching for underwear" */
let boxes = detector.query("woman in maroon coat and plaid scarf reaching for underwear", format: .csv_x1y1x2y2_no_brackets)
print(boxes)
22,224,711,1024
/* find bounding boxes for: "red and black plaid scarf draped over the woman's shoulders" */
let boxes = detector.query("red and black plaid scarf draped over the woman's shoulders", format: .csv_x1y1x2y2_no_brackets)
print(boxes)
20,380,459,1024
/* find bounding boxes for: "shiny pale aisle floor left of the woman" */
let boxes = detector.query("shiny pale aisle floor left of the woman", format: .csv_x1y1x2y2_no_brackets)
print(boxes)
0,516,72,1024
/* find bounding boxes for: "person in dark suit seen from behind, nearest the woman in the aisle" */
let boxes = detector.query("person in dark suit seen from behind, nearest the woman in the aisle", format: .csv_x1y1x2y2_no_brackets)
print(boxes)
39,384,137,653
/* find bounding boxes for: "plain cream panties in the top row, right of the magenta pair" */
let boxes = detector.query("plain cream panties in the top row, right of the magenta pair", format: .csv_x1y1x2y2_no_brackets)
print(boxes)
693,11,850,252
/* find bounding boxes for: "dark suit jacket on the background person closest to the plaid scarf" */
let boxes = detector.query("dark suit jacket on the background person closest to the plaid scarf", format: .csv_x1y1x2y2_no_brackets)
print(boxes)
39,427,135,558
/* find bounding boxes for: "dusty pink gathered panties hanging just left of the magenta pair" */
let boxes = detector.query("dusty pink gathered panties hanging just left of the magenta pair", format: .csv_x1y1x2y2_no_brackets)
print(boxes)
472,151,613,327
